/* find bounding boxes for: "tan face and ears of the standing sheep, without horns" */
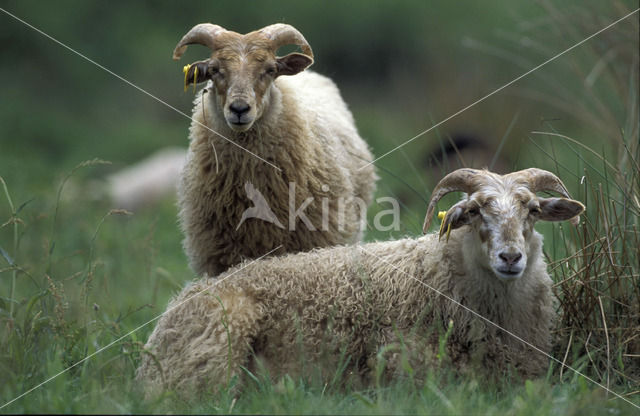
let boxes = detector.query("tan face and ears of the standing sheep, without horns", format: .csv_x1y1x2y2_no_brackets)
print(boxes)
182,32,313,132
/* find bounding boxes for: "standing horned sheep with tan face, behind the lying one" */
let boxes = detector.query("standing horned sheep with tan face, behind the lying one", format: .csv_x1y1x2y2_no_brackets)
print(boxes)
173,23,376,276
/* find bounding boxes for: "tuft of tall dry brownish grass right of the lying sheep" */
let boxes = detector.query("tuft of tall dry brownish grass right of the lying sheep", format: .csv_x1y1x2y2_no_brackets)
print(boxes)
551,148,640,394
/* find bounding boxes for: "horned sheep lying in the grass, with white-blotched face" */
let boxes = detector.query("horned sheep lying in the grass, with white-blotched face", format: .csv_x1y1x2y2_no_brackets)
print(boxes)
137,169,584,393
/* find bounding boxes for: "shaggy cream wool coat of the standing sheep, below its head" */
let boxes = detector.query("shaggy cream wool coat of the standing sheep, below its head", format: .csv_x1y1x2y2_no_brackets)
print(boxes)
178,71,376,276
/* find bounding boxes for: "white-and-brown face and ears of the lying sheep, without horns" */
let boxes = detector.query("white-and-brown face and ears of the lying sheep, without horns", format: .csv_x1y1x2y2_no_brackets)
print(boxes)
444,181,584,281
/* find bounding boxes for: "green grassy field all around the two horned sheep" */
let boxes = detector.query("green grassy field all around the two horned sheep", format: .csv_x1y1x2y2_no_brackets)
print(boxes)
0,1,640,415
